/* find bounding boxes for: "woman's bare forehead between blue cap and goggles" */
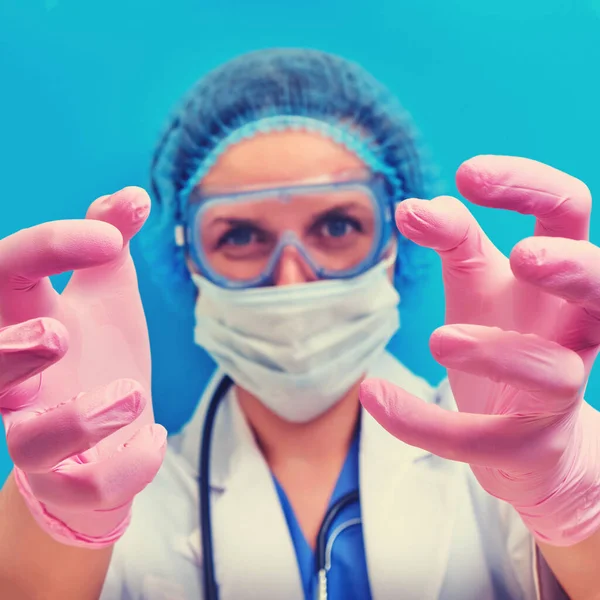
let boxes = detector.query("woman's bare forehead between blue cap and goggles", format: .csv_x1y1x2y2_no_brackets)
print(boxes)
201,131,368,194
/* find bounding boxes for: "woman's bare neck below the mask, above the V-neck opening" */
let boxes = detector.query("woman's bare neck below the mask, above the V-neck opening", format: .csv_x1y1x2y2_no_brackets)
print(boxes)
236,382,360,467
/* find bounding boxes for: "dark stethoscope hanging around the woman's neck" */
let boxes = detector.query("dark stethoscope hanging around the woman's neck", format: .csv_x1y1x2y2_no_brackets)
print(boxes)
198,375,361,600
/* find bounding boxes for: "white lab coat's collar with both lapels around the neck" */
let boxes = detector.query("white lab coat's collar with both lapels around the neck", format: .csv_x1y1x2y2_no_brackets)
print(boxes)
176,355,456,600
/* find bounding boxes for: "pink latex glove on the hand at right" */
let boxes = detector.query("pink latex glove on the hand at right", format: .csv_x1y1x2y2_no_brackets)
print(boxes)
361,156,600,546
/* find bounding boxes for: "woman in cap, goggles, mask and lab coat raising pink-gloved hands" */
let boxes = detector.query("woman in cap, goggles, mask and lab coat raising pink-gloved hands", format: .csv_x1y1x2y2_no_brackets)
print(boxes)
0,50,600,600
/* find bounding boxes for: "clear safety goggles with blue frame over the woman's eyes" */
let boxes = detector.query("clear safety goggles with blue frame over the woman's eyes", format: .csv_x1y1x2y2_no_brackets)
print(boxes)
185,175,393,288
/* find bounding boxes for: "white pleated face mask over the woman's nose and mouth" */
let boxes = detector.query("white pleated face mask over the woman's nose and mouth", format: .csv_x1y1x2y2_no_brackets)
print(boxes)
192,257,400,423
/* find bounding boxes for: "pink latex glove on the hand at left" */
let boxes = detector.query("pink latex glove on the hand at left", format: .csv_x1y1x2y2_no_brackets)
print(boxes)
0,188,166,547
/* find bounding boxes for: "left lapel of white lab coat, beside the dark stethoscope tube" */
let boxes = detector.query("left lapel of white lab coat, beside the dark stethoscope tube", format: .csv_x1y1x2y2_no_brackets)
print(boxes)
211,382,303,600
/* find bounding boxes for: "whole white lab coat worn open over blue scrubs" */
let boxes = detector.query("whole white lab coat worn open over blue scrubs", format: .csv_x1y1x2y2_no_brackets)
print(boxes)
101,354,566,600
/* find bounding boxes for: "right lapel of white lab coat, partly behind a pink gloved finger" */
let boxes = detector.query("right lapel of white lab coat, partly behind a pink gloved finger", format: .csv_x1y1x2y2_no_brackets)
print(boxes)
360,356,459,600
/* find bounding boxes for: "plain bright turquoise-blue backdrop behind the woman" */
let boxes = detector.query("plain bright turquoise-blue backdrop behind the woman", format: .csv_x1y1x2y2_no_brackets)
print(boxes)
0,0,600,481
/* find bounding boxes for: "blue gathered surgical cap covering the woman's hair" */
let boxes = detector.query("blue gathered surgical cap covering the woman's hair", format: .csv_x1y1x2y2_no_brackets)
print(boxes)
140,48,428,304
